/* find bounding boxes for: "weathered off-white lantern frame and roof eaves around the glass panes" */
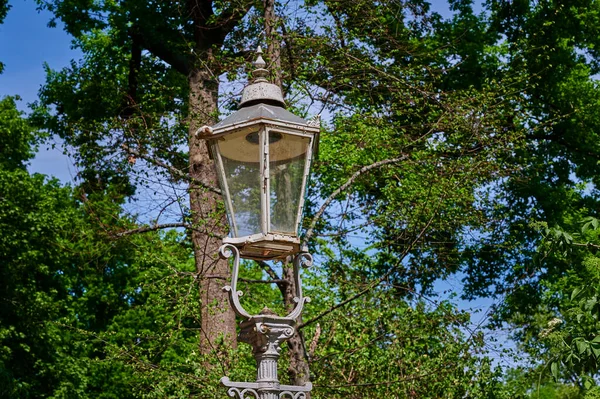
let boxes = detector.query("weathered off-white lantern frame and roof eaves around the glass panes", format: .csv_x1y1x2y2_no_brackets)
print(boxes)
208,100,320,260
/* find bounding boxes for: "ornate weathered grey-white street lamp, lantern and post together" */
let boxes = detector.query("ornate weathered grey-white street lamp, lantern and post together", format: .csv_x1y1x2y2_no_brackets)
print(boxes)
205,47,320,399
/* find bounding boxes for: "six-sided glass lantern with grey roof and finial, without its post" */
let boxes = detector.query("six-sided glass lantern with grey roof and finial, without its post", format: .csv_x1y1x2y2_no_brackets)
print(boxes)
210,51,320,260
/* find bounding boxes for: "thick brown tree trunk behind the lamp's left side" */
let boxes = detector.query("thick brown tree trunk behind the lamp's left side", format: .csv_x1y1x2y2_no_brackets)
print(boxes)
188,50,237,361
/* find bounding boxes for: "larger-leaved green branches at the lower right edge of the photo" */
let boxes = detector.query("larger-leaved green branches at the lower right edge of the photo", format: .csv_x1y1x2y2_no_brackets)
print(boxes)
510,216,600,391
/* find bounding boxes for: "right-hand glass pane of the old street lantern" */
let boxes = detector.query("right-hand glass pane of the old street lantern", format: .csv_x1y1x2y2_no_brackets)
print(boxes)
269,132,310,235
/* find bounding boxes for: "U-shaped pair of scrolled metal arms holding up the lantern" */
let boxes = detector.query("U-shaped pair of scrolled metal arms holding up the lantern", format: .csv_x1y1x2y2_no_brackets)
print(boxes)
219,243,313,320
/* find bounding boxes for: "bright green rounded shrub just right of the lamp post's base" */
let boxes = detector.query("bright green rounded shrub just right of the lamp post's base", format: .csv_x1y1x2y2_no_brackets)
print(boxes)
305,289,499,398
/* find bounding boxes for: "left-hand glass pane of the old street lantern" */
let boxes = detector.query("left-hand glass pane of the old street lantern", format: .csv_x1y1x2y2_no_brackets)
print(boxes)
217,129,262,237
